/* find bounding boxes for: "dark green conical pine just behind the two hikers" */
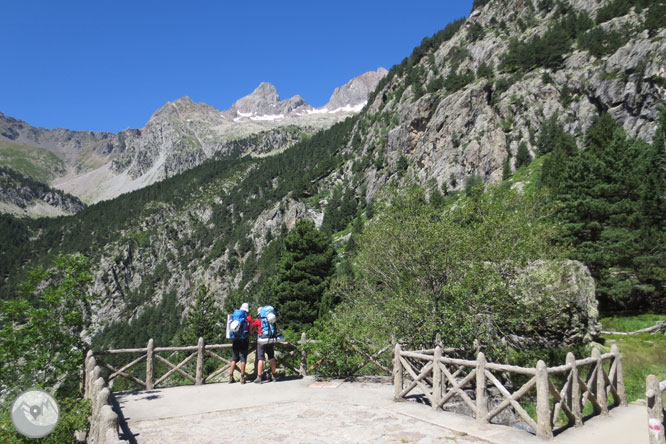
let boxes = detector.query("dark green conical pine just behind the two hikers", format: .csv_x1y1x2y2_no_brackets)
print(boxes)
272,220,334,330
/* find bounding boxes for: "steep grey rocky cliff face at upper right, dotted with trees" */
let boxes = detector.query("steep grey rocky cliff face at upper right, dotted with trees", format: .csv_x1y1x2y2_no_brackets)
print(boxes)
340,0,666,198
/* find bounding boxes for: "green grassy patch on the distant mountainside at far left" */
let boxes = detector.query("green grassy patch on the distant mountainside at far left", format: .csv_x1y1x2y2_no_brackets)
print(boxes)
0,140,65,183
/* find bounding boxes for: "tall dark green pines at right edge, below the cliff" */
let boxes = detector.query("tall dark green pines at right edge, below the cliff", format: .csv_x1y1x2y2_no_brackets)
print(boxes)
542,114,664,307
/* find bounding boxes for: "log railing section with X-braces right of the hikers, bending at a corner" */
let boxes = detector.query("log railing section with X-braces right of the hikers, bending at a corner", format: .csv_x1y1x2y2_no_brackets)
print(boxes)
393,344,627,438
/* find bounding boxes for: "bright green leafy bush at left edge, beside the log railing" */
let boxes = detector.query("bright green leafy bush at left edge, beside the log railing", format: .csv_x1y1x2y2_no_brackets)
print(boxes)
0,255,92,396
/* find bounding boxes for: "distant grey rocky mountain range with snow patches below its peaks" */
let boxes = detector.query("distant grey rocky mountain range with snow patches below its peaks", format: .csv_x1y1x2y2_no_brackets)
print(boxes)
0,68,387,215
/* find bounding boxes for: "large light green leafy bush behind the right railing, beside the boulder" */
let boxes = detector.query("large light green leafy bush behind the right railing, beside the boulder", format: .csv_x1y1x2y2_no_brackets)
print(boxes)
317,186,563,372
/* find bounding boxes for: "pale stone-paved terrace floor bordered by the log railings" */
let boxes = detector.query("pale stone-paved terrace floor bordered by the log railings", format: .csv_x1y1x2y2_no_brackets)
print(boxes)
115,378,648,444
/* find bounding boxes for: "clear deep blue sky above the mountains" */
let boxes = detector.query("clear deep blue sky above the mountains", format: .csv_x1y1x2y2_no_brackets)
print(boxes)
0,0,472,132
